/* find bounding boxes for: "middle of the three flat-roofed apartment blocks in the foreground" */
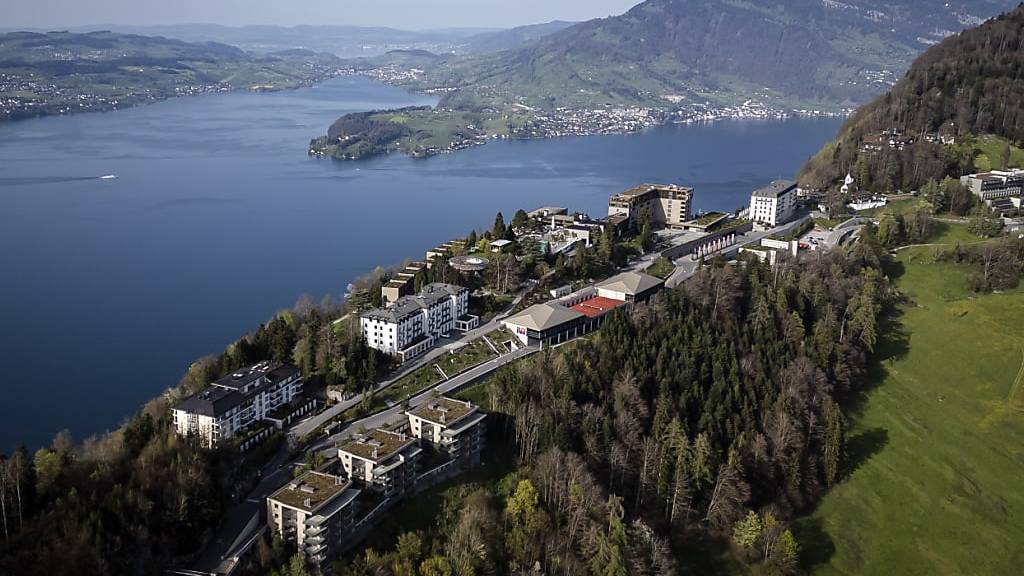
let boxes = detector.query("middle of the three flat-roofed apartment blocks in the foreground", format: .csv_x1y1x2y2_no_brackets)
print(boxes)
338,428,423,498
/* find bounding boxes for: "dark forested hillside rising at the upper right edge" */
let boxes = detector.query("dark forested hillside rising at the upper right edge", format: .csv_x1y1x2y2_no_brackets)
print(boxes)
800,5,1024,191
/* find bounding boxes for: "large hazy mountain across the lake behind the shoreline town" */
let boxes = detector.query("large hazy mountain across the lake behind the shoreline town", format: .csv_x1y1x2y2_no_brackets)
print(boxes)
413,0,1016,110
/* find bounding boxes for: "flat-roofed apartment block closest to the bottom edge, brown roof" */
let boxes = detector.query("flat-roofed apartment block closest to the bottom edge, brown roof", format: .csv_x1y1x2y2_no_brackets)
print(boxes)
266,471,360,567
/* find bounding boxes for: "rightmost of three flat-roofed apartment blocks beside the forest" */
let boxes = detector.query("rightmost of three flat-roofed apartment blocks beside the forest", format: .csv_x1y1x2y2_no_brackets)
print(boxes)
406,397,486,464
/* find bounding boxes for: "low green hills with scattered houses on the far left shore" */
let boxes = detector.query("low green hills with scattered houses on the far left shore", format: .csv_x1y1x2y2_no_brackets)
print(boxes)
0,32,341,120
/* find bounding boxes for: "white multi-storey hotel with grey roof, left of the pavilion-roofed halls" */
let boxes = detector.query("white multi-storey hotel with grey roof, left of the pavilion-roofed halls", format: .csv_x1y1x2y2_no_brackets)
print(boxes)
359,283,479,362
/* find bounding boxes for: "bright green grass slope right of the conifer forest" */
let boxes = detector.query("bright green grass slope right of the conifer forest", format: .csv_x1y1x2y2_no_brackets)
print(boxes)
797,240,1024,575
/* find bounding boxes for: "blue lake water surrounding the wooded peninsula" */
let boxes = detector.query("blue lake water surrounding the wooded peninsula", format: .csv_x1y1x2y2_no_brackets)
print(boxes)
0,78,840,452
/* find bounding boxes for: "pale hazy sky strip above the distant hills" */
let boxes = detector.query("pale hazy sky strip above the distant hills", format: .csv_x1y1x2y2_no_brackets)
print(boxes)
0,0,640,30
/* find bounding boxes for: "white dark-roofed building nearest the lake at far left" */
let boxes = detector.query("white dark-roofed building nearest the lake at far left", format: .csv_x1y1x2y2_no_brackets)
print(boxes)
171,362,302,447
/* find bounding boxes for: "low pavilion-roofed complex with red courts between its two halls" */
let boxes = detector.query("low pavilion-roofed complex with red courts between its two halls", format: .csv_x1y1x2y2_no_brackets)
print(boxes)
502,272,665,345
